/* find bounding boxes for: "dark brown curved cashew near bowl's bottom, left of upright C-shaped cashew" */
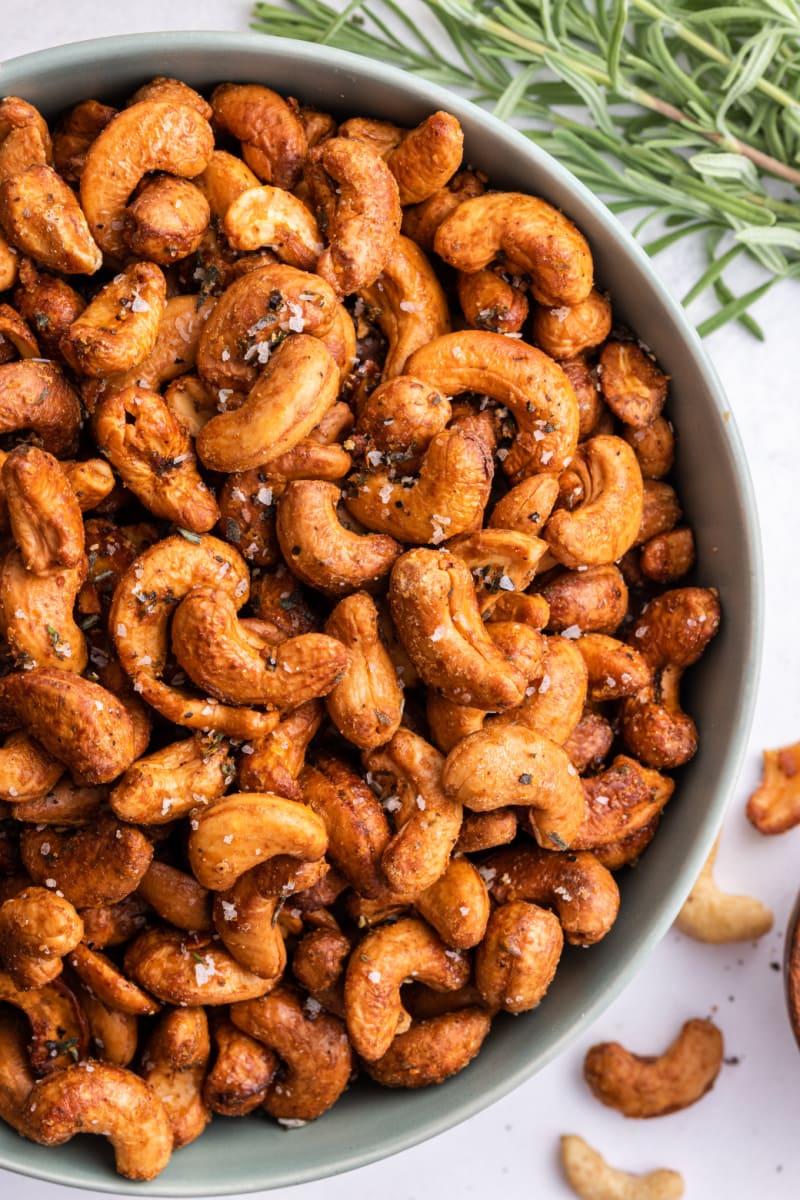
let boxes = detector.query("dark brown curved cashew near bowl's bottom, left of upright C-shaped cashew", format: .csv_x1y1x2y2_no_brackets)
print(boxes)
230,988,353,1121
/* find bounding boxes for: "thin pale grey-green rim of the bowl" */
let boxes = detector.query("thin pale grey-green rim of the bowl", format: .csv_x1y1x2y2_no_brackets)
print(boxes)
0,30,765,1196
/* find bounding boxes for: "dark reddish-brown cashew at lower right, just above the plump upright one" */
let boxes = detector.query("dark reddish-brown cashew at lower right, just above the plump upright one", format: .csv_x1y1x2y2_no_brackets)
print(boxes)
481,846,619,946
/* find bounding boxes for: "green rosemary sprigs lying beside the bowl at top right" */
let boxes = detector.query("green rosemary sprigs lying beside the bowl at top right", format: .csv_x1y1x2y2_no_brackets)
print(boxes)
253,0,800,337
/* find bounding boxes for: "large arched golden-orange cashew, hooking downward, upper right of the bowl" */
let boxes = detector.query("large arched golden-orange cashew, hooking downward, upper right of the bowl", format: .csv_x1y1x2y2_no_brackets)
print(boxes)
404,330,578,482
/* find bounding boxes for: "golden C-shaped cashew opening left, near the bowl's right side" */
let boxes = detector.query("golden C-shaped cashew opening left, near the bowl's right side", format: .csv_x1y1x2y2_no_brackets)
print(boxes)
543,436,643,568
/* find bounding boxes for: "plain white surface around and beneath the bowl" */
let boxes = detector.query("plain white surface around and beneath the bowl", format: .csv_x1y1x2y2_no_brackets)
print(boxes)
0,0,800,1200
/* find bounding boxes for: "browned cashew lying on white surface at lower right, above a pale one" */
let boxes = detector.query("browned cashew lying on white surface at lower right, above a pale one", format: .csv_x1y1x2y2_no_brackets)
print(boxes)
583,1020,723,1117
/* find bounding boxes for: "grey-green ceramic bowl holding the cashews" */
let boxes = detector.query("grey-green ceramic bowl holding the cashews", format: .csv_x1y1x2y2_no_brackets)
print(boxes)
0,32,762,1196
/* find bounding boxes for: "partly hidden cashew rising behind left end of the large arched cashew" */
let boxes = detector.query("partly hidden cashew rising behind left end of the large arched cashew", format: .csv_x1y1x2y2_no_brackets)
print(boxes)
360,236,450,380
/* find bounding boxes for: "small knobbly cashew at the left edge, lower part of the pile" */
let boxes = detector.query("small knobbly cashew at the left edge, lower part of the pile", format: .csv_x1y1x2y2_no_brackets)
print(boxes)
0,887,84,989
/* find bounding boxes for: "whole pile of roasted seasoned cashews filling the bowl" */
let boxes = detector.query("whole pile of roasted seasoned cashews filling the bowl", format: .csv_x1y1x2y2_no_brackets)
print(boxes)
0,78,720,1180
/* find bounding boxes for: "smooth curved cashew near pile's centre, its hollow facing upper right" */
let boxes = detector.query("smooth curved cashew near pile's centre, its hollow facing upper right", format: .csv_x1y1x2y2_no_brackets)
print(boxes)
277,479,402,596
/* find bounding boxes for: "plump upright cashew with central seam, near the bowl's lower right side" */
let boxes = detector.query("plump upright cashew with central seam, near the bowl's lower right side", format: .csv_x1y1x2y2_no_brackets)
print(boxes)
475,900,564,1013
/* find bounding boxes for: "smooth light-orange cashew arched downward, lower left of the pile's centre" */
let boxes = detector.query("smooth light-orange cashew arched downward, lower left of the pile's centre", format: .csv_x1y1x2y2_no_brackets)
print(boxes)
188,792,327,892
